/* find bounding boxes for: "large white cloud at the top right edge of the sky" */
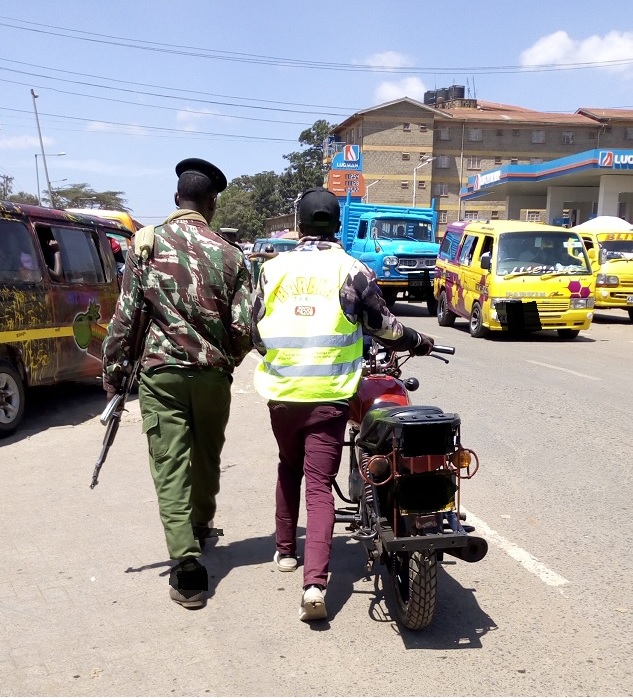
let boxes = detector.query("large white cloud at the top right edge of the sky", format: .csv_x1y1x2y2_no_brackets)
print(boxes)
521,30,633,71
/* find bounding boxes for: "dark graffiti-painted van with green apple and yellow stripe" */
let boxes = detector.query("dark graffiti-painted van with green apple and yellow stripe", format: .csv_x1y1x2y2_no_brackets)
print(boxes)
0,202,131,436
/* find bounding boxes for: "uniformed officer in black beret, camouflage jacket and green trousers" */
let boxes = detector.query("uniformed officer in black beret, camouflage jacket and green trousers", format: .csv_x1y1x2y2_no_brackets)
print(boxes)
103,158,252,607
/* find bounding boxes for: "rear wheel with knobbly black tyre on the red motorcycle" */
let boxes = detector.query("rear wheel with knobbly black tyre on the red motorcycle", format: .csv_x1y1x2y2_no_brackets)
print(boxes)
389,552,437,630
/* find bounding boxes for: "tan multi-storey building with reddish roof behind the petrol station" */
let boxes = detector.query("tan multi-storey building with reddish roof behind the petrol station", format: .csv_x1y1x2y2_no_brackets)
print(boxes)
324,90,633,234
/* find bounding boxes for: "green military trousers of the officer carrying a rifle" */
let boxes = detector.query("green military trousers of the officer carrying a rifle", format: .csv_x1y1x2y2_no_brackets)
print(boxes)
139,368,231,560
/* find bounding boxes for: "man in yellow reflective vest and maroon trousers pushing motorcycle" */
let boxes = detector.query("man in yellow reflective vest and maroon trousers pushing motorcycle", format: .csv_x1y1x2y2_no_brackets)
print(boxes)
253,188,433,621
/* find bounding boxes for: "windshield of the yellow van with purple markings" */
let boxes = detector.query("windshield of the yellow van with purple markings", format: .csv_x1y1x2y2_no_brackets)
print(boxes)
496,231,591,276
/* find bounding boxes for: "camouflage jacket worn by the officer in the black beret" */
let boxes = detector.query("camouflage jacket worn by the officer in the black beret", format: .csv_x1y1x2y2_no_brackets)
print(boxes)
103,210,252,390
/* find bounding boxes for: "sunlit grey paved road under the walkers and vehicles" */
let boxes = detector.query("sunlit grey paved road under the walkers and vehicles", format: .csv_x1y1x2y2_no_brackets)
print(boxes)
0,304,633,696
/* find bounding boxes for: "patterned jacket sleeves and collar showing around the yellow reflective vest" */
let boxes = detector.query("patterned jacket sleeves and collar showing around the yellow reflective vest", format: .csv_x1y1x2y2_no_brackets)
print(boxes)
253,237,408,354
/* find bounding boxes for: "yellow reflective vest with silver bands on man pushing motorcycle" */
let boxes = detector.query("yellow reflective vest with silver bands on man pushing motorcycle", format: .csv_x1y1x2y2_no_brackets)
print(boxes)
254,247,363,402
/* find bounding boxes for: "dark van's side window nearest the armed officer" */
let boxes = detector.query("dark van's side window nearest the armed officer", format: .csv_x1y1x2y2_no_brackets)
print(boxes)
52,226,106,284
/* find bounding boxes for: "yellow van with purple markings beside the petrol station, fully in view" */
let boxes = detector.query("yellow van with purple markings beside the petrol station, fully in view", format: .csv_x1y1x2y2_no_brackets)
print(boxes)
433,221,596,339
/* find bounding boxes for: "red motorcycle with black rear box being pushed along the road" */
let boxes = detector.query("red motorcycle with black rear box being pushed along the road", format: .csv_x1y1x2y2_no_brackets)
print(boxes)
334,341,488,630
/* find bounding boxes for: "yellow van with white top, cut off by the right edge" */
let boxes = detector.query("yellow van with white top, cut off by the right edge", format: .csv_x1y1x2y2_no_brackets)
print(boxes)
571,216,633,320
